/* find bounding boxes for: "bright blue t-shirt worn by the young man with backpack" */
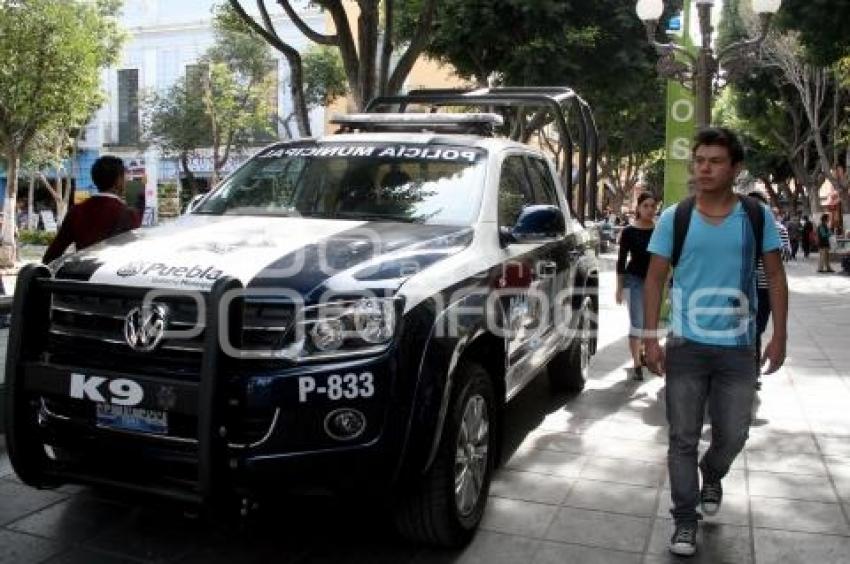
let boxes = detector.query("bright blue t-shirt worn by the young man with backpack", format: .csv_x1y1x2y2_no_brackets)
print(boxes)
649,202,782,347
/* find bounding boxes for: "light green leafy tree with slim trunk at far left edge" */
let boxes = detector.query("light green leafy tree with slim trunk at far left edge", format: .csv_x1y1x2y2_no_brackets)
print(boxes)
0,0,123,263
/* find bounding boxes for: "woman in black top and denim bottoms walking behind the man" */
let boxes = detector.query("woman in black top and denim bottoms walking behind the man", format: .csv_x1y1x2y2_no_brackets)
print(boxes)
616,192,658,380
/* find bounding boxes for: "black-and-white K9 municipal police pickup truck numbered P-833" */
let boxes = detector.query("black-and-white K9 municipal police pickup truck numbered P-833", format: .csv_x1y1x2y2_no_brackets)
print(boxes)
6,88,598,546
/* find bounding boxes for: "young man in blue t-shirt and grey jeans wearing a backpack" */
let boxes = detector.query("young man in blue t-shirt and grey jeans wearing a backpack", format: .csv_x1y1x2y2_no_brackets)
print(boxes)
644,128,788,556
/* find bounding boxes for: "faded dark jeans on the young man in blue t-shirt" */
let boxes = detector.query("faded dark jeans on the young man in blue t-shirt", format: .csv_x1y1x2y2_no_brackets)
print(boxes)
666,336,756,523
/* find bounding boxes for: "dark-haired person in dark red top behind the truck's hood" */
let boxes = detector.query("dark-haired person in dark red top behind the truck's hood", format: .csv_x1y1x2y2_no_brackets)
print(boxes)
42,156,140,264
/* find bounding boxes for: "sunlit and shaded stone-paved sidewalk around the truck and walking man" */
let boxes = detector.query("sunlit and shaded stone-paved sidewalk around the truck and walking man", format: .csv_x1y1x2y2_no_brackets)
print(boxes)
0,257,850,564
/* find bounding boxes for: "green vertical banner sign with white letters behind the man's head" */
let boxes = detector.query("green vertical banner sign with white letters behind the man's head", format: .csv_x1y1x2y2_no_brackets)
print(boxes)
664,0,696,207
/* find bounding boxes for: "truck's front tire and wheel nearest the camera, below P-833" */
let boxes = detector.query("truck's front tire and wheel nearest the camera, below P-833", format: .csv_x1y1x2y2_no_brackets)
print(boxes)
395,362,498,548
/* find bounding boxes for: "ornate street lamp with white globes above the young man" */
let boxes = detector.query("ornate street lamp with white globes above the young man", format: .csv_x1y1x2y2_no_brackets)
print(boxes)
636,0,782,127
